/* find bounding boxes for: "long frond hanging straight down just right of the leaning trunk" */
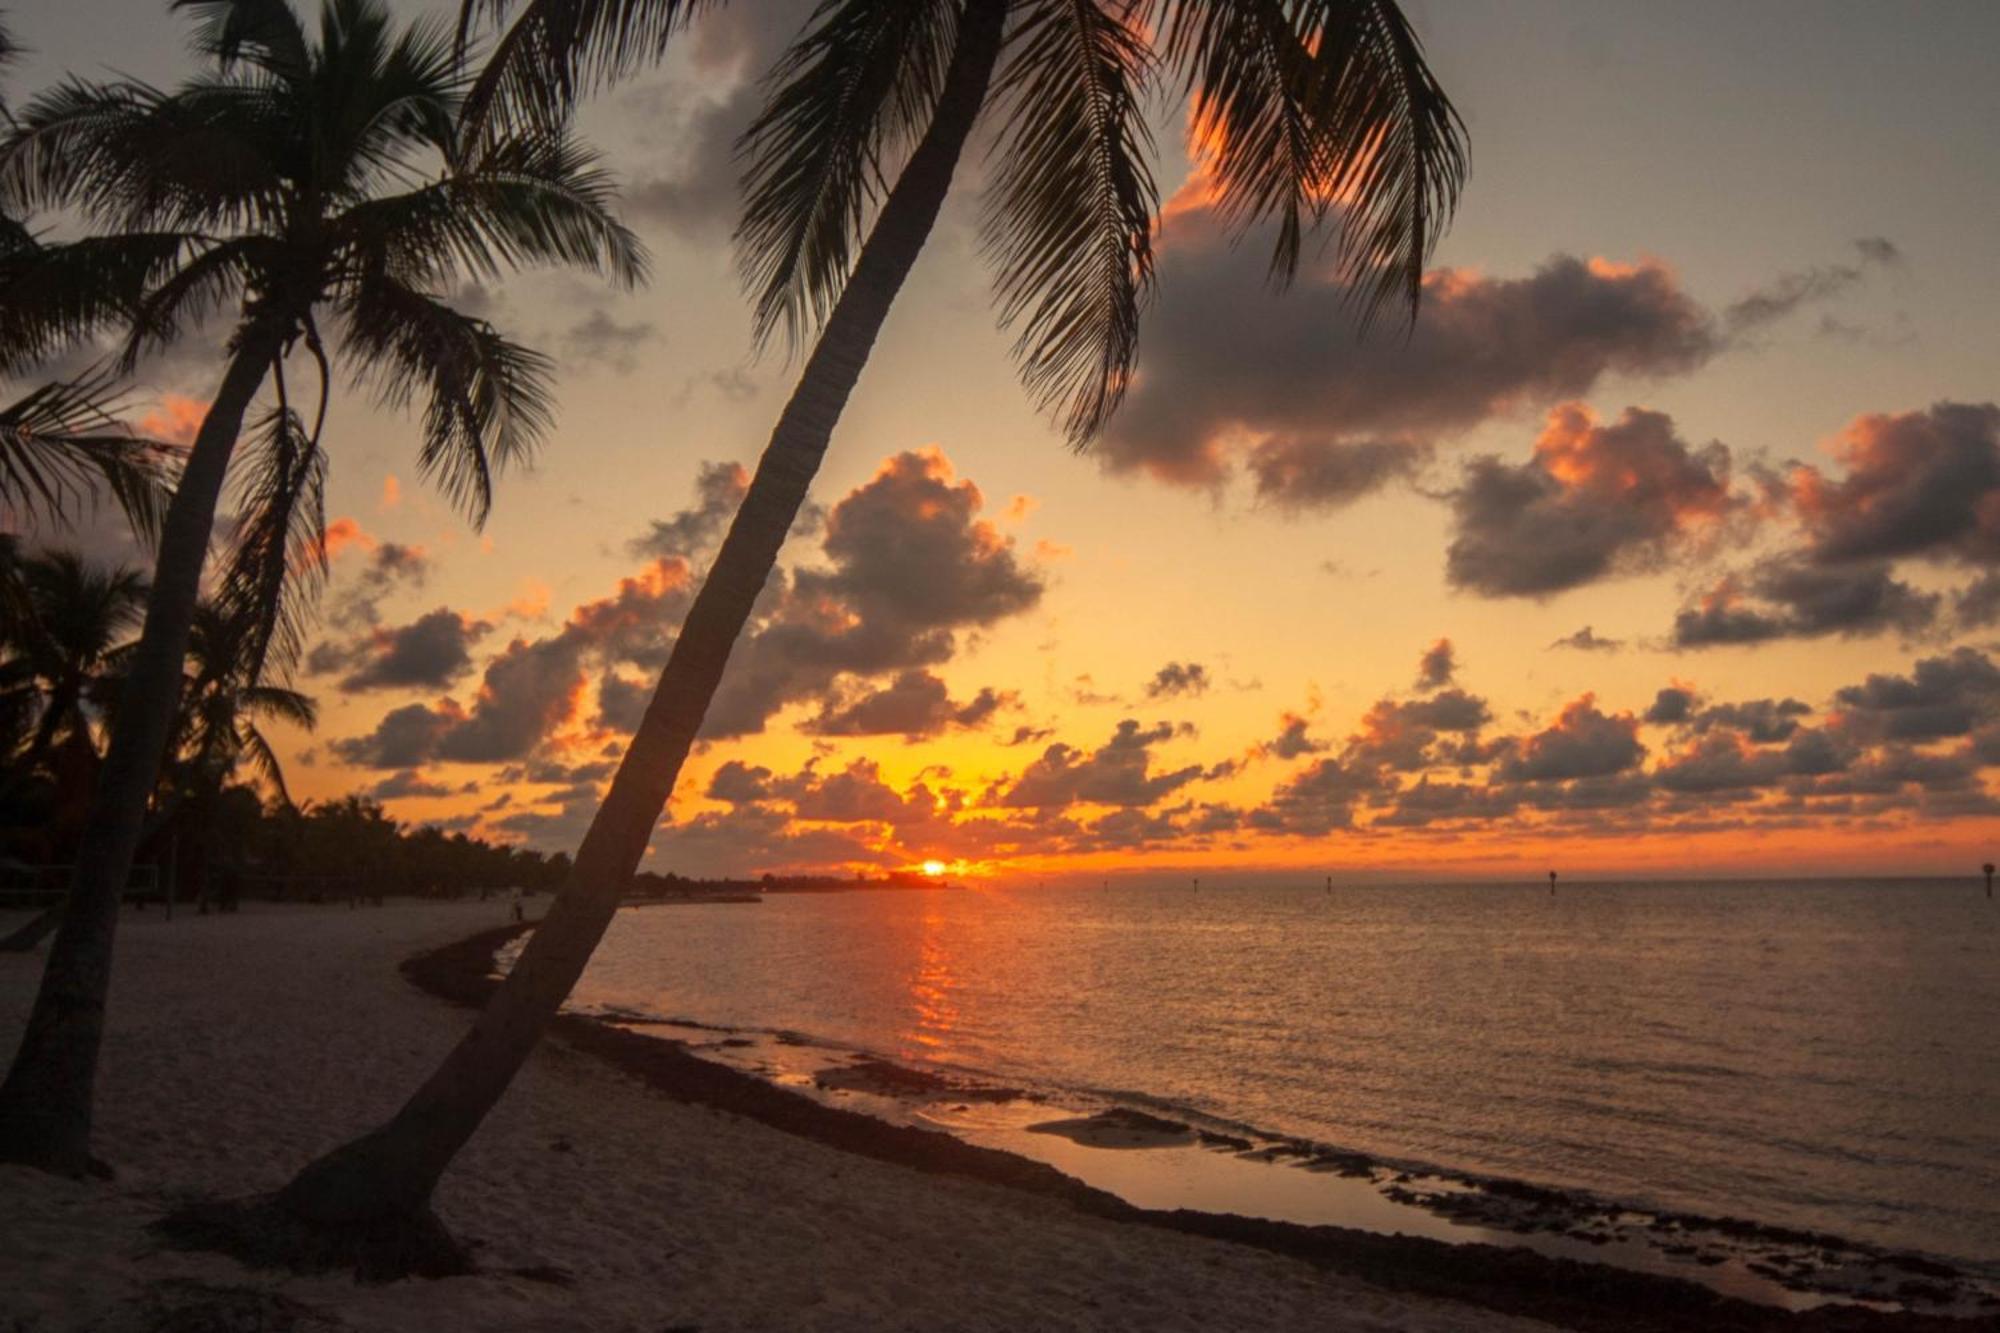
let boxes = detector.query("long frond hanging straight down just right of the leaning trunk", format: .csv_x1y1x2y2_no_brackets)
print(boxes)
982,0,1160,446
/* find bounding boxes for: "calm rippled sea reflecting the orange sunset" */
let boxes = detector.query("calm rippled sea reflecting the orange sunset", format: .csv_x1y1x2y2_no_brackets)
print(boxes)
578,881,2000,1267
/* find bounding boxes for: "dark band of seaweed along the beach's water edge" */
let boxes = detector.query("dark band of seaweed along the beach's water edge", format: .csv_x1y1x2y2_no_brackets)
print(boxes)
430,923,1976,1333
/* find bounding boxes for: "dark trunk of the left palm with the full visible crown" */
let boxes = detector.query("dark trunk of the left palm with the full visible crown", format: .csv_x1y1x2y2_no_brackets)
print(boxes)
0,320,278,1175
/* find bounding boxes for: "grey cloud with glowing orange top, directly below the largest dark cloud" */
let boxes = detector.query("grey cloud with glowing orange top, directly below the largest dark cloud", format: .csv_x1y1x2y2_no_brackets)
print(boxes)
1446,402,1736,596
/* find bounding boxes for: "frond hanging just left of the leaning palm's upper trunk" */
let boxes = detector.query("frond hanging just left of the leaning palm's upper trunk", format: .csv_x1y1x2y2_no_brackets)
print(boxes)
736,0,958,348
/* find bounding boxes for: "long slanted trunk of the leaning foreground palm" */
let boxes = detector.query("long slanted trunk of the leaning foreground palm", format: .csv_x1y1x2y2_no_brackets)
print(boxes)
278,0,1006,1225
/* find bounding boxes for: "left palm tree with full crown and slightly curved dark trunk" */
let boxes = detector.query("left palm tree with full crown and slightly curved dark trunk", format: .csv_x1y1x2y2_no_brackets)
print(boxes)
0,0,646,1175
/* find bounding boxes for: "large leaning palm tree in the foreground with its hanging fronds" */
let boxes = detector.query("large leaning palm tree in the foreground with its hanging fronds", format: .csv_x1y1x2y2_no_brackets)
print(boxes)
258,0,1464,1237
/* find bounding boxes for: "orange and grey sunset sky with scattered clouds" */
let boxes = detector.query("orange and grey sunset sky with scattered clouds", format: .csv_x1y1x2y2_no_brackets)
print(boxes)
10,0,2000,881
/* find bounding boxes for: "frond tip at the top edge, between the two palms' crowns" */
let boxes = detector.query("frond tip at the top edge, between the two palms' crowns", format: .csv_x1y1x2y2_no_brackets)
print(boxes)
458,0,720,142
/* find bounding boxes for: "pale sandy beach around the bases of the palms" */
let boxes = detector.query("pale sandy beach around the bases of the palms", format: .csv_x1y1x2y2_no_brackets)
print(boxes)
0,903,1540,1333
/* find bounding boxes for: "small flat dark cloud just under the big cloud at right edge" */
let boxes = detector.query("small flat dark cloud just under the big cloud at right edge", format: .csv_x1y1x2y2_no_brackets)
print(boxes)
1672,556,1940,648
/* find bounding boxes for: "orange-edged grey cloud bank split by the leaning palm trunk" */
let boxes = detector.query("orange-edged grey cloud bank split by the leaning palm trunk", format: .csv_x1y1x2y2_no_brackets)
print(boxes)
334,450,1042,767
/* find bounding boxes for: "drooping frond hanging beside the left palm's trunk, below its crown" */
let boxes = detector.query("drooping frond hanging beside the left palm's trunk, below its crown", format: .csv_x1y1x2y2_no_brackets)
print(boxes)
216,404,326,683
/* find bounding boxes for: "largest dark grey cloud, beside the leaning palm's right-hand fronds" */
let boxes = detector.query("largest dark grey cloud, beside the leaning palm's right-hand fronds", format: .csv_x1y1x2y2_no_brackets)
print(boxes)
1100,208,1720,506
